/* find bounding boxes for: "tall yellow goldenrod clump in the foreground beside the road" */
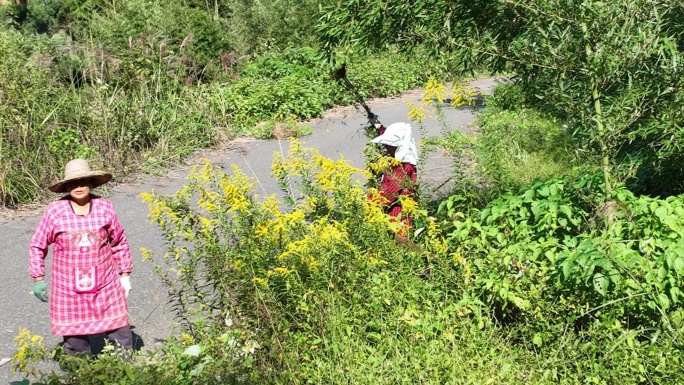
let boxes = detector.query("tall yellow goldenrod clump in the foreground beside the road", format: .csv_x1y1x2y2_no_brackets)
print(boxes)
143,142,390,318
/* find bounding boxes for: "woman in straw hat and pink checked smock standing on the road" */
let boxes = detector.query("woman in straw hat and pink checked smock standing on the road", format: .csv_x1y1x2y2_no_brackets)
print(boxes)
29,159,133,356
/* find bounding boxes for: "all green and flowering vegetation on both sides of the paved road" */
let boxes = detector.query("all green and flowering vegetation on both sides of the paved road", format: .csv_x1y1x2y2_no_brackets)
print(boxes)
8,0,684,384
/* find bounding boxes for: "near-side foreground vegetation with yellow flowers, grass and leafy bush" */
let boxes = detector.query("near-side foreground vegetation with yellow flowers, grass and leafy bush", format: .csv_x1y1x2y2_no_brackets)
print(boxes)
17,83,684,384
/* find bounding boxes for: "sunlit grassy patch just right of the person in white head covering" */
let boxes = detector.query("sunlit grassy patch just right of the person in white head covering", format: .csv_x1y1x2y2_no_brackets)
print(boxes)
421,83,587,214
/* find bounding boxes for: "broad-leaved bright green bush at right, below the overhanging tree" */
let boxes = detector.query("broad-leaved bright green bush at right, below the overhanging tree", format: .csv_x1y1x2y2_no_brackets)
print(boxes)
443,173,684,344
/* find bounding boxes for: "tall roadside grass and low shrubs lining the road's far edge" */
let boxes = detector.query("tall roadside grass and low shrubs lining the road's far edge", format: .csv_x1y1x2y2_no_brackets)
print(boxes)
0,29,446,206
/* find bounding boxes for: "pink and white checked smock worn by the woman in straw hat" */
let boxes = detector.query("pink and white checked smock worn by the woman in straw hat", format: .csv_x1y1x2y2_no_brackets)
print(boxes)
29,196,133,336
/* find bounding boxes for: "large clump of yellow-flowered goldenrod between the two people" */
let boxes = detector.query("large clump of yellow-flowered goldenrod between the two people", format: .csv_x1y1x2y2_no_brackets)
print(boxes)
143,142,454,380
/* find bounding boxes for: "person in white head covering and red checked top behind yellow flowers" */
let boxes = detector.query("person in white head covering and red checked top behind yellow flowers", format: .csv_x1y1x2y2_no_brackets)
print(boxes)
372,122,418,237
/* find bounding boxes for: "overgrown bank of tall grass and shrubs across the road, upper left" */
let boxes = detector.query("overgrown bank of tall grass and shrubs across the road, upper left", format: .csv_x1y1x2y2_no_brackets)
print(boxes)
0,0,439,206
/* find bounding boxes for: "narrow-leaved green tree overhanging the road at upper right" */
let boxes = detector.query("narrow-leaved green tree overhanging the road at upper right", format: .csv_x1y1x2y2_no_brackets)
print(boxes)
318,0,684,195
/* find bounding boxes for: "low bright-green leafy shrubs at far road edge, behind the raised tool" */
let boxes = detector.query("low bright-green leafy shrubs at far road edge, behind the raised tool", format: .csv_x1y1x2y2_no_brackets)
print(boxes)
209,48,439,133
